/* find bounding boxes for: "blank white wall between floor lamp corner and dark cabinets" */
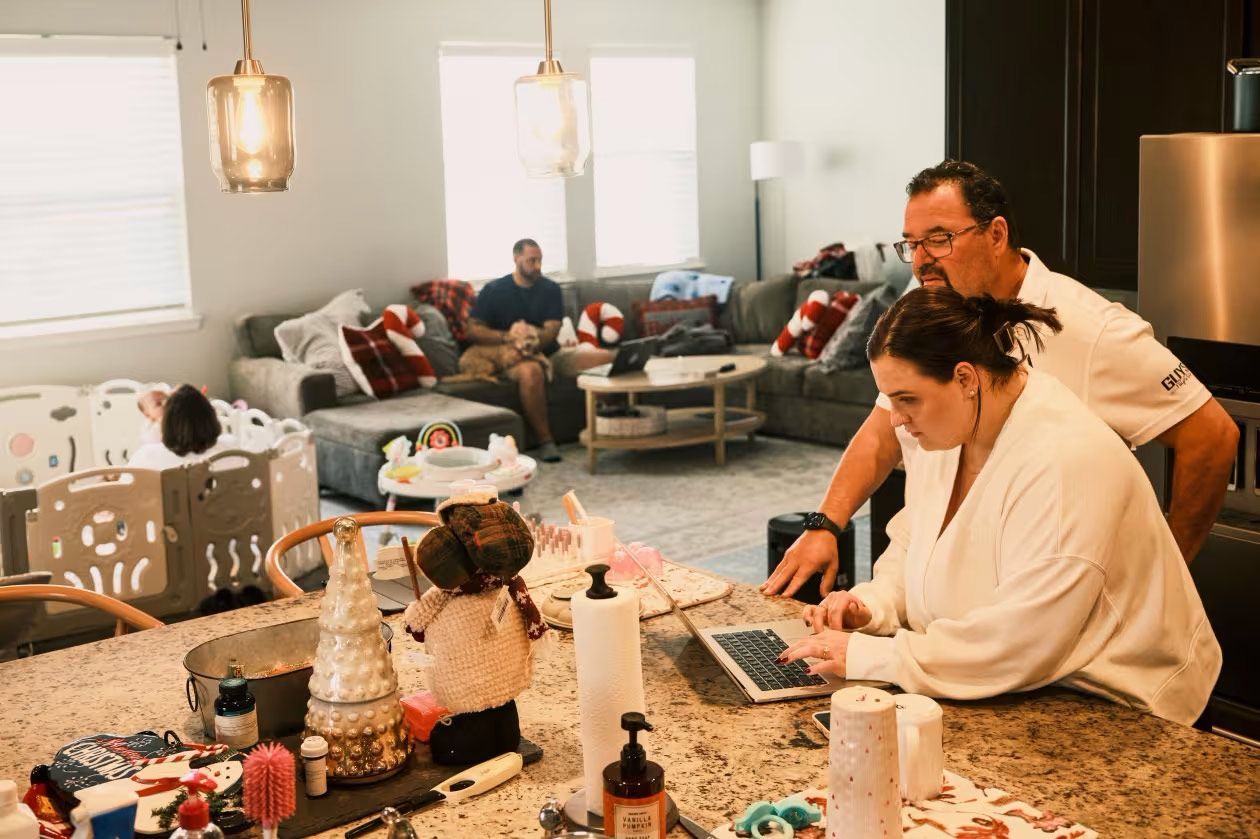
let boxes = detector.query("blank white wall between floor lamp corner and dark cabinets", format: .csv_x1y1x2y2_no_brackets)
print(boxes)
761,0,945,275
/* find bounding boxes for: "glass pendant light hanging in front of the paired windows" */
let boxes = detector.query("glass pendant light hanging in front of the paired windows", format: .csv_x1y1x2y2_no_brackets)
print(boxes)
517,0,591,178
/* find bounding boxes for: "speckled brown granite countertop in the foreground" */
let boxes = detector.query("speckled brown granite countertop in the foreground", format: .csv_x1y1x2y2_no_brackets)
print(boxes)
0,585,1260,836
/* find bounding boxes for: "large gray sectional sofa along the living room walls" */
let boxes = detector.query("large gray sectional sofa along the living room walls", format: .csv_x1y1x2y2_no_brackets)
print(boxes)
229,263,908,504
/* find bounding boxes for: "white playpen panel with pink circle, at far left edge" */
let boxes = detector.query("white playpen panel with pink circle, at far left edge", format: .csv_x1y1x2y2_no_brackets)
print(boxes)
0,384,93,489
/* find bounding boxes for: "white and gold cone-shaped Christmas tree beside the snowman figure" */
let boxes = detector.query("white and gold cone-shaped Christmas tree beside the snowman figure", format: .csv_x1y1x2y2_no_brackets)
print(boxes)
306,518,411,782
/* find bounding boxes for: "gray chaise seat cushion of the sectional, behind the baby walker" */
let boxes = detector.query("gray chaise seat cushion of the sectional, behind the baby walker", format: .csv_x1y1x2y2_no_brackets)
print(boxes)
302,391,519,460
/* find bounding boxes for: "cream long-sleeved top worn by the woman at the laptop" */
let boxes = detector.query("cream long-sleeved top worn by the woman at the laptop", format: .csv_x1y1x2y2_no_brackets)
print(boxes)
847,370,1221,724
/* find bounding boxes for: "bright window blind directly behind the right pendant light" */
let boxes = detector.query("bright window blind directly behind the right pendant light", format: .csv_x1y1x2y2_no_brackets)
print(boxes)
438,48,568,280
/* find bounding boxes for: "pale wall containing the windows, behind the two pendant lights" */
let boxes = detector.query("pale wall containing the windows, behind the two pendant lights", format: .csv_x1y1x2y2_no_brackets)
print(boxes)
0,0,761,393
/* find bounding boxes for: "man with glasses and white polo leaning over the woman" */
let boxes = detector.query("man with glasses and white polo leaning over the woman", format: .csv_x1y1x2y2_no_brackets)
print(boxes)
761,160,1239,595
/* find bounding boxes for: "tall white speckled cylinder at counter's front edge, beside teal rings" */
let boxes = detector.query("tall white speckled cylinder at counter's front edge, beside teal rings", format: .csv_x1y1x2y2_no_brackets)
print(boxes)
827,688,901,839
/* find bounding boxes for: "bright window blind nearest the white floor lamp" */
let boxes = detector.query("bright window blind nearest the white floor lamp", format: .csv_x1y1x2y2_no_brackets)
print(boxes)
591,55,701,268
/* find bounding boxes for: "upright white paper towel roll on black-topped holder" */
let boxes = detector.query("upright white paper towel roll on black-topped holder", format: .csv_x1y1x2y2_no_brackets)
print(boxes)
572,569,646,816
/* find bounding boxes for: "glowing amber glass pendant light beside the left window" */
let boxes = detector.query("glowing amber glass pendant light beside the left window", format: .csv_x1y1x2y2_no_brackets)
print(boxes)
205,0,294,193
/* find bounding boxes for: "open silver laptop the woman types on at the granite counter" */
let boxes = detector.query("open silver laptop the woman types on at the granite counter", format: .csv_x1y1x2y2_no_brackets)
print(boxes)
626,549,888,704
